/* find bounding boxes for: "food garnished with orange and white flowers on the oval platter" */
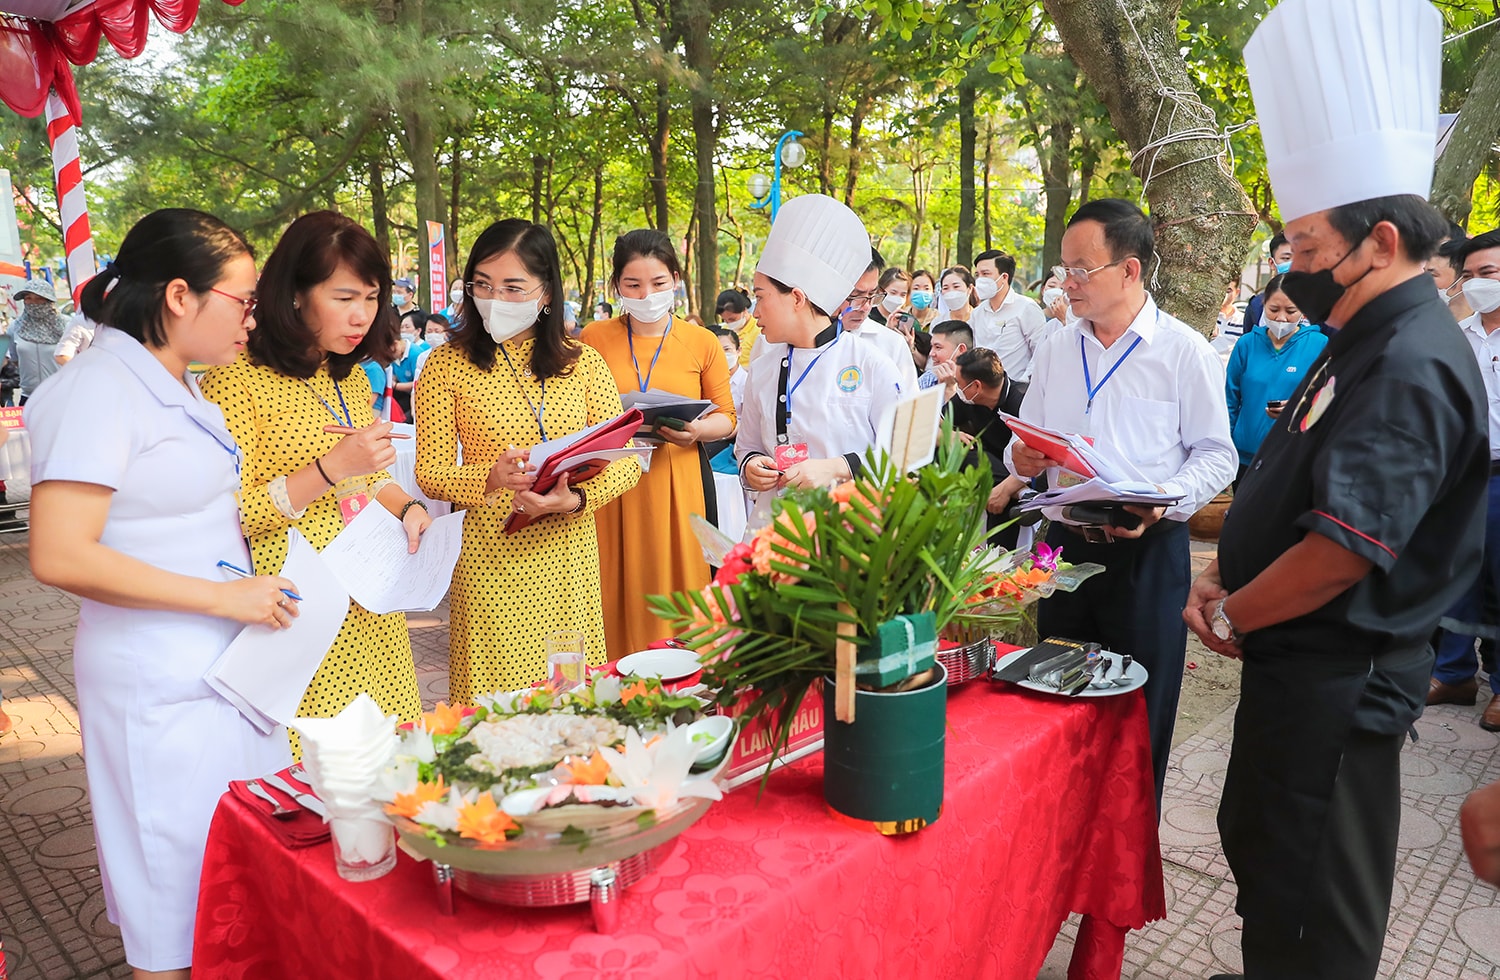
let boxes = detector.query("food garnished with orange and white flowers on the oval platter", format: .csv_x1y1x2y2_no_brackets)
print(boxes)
377,674,720,849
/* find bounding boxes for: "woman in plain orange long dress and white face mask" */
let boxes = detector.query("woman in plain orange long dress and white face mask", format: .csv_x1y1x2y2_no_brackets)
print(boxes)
581,228,735,657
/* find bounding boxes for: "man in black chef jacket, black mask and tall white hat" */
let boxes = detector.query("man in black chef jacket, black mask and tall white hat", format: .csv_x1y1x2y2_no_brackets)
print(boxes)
1184,0,1488,980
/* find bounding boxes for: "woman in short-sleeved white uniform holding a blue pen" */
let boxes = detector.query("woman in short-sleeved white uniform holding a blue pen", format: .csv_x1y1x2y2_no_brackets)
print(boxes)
26,209,296,980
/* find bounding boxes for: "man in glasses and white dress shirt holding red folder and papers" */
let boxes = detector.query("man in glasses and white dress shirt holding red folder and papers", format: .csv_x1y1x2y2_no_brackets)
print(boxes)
1007,198,1239,803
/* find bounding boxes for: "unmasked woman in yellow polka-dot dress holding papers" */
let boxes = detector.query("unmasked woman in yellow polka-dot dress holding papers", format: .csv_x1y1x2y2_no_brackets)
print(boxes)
203,212,432,752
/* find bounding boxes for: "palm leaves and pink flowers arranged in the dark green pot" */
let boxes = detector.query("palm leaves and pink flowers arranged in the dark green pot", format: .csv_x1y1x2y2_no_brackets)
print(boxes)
651,425,999,765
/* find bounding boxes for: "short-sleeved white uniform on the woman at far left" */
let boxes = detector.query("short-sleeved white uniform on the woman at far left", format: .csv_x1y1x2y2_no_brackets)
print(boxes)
26,327,291,971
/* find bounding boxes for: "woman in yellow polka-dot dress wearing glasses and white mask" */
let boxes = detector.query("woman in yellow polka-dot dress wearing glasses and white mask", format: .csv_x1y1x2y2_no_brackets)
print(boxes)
414,218,642,704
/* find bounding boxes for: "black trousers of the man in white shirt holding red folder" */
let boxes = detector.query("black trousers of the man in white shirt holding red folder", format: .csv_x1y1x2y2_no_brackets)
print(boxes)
1037,521,1193,810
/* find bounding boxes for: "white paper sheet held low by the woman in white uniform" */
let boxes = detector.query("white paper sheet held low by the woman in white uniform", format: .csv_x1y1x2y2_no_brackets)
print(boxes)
203,528,350,734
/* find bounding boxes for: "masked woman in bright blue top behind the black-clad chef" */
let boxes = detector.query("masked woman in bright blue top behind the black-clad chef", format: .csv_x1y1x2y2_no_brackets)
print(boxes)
1224,276,1328,486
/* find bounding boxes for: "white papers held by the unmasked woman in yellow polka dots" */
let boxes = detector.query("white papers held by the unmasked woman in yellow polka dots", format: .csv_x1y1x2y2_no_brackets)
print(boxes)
323,506,467,614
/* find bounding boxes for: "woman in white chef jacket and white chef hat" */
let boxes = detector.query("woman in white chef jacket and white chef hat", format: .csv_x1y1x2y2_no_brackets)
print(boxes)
735,194,902,513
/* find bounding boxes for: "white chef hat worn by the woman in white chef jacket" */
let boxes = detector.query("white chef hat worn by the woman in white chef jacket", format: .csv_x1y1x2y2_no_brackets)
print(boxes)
756,194,870,314
